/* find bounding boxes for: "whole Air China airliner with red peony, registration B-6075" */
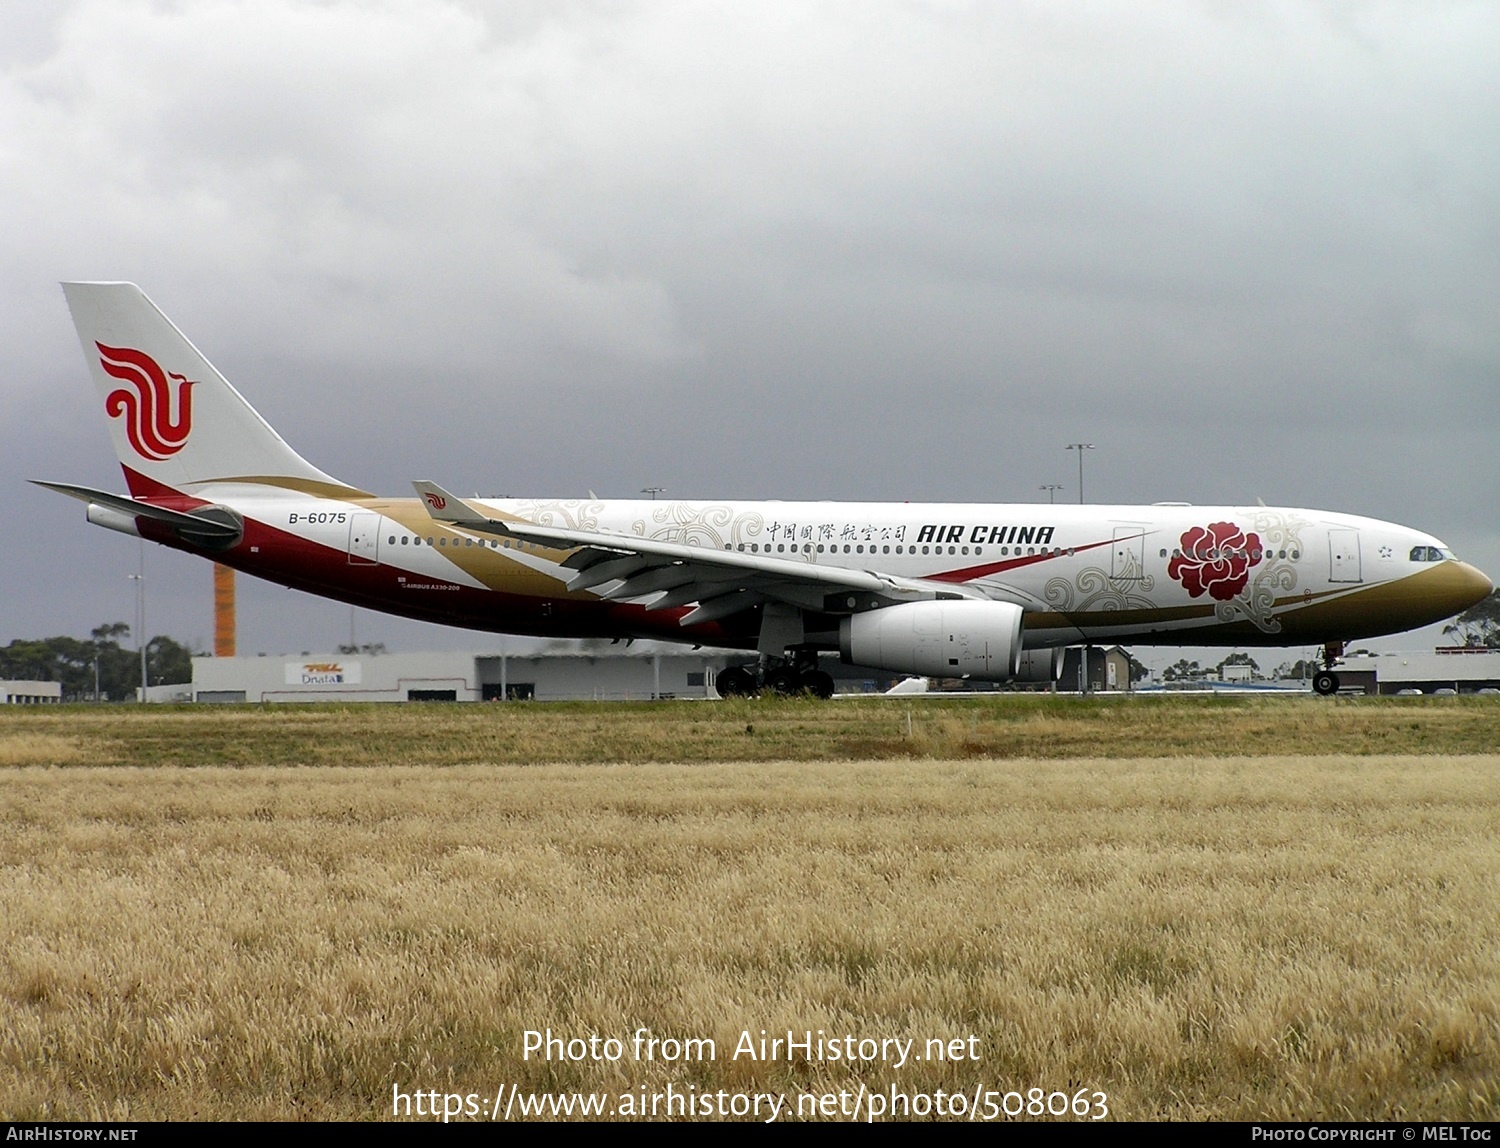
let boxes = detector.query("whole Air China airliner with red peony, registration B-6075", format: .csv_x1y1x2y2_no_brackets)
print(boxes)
39,282,1493,696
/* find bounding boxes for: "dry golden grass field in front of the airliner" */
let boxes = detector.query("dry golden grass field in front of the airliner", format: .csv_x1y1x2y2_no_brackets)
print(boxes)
0,696,1500,1119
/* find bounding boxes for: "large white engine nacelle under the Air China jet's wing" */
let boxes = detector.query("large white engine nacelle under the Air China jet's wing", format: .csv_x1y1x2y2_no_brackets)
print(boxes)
839,599,1022,681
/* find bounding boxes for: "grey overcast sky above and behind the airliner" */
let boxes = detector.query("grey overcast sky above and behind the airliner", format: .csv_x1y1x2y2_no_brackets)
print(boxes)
0,0,1500,662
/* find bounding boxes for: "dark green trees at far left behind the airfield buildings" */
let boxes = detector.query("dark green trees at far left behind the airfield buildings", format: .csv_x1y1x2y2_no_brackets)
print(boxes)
0,621,194,701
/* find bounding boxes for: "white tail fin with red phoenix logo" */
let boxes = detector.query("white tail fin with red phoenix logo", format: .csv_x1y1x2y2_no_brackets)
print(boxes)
63,284,363,497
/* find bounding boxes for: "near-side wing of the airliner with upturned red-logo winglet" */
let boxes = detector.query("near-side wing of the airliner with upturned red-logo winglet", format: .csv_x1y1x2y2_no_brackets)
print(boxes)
413,482,1035,626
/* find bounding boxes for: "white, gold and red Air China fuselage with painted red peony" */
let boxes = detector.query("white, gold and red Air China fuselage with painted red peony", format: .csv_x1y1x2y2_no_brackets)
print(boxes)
194,486,1488,647
